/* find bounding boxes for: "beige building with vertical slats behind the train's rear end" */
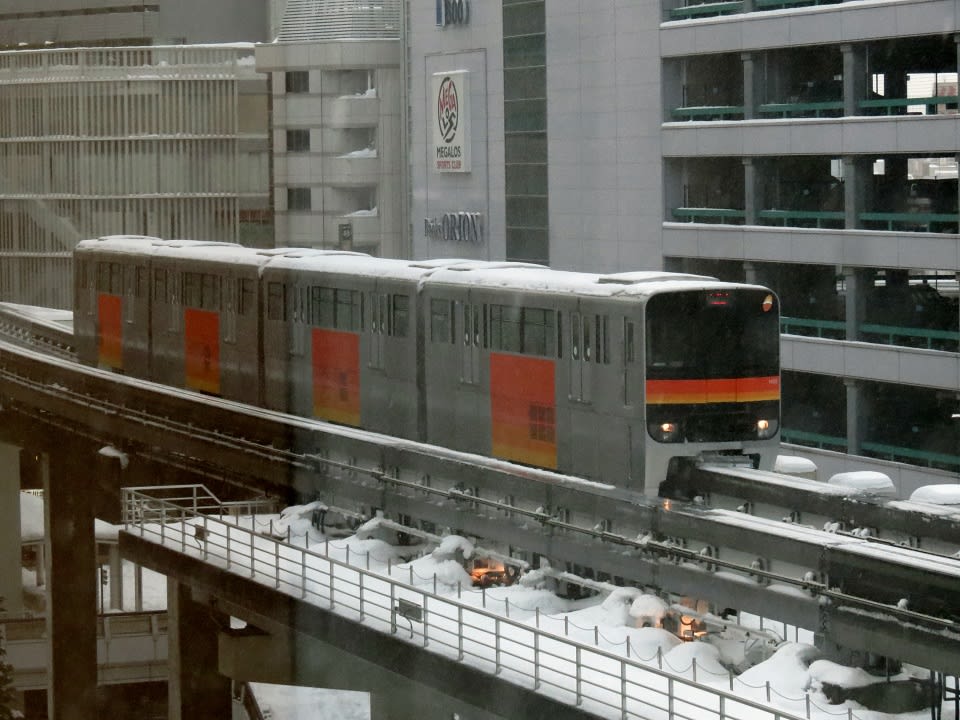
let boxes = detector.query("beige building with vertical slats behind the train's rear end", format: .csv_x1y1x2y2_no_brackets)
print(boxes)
0,46,269,307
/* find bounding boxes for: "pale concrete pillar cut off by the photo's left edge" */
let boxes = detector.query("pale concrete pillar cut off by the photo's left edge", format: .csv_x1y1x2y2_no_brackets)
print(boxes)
0,443,23,615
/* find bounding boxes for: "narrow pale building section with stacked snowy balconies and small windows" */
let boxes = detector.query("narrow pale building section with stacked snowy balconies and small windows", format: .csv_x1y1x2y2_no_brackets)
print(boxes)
257,0,409,257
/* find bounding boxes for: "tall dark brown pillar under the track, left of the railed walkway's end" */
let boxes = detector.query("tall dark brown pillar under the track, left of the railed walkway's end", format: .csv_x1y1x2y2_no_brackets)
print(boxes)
40,440,97,720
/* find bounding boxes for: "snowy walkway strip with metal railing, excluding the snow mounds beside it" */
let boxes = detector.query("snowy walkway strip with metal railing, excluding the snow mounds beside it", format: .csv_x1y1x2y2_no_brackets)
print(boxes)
124,488,853,720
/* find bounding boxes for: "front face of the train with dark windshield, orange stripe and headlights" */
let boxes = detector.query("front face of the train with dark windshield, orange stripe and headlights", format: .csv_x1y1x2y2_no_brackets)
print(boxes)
644,286,780,485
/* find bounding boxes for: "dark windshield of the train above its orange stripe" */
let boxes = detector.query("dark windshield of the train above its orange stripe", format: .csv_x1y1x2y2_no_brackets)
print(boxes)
646,289,780,379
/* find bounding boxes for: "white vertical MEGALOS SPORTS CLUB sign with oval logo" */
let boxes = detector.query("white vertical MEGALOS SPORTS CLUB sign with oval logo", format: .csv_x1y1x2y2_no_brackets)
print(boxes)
433,70,470,172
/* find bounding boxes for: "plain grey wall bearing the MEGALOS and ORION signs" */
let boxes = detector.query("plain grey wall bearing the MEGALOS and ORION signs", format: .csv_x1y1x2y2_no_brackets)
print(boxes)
406,0,662,271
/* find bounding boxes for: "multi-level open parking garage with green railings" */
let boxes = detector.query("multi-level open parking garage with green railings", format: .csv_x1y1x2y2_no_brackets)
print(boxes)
659,0,960,492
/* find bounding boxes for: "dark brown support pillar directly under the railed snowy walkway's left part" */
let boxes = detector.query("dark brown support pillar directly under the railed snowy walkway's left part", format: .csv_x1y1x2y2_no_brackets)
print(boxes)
167,578,231,720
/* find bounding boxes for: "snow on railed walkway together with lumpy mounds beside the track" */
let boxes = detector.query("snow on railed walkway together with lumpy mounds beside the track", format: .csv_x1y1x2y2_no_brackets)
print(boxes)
118,490,957,720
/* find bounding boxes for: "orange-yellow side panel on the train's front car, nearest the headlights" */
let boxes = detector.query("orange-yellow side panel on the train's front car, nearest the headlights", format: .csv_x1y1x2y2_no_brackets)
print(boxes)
490,353,557,469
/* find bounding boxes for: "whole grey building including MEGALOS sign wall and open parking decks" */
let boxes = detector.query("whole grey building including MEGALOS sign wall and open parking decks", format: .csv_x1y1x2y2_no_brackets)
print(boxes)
405,0,960,494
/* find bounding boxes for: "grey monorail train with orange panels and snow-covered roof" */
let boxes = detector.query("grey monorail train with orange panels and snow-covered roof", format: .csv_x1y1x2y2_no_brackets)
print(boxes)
74,236,780,495
